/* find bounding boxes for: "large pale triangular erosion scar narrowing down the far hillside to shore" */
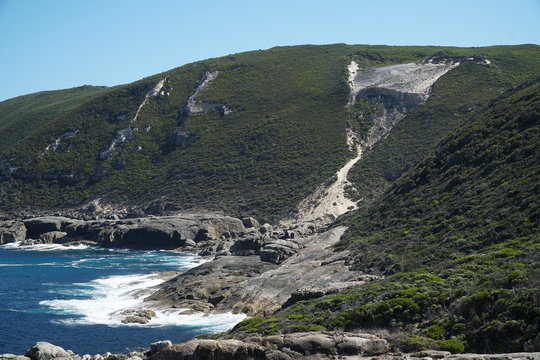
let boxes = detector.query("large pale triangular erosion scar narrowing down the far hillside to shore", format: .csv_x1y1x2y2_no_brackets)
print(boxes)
280,60,459,226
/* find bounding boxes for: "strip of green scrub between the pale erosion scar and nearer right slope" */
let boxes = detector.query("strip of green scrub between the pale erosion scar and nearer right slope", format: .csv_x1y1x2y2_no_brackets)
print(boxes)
349,45,540,203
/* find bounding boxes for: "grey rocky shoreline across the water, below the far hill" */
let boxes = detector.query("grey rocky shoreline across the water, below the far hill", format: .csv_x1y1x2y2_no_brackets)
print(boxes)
0,214,379,323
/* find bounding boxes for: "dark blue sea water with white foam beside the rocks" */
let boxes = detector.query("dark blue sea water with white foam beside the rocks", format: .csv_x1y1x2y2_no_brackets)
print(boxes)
0,244,245,355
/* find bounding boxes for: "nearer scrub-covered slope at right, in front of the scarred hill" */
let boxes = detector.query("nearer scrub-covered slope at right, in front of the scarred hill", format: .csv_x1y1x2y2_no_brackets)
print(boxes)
233,79,540,352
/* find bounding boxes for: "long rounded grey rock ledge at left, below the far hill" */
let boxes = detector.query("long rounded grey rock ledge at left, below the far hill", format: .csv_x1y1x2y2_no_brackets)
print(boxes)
16,214,249,249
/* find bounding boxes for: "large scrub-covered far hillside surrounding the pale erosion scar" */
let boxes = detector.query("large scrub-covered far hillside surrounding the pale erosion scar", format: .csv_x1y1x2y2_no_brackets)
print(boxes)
0,44,540,222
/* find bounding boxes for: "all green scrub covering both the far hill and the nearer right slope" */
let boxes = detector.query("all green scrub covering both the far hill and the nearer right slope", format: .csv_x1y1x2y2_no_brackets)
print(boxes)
0,44,540,352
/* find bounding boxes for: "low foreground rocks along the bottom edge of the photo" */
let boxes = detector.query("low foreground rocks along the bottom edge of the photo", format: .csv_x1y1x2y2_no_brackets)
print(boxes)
4,338,540,360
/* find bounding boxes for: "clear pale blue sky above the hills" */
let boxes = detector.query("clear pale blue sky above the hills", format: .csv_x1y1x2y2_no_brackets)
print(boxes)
0,0,540,100
